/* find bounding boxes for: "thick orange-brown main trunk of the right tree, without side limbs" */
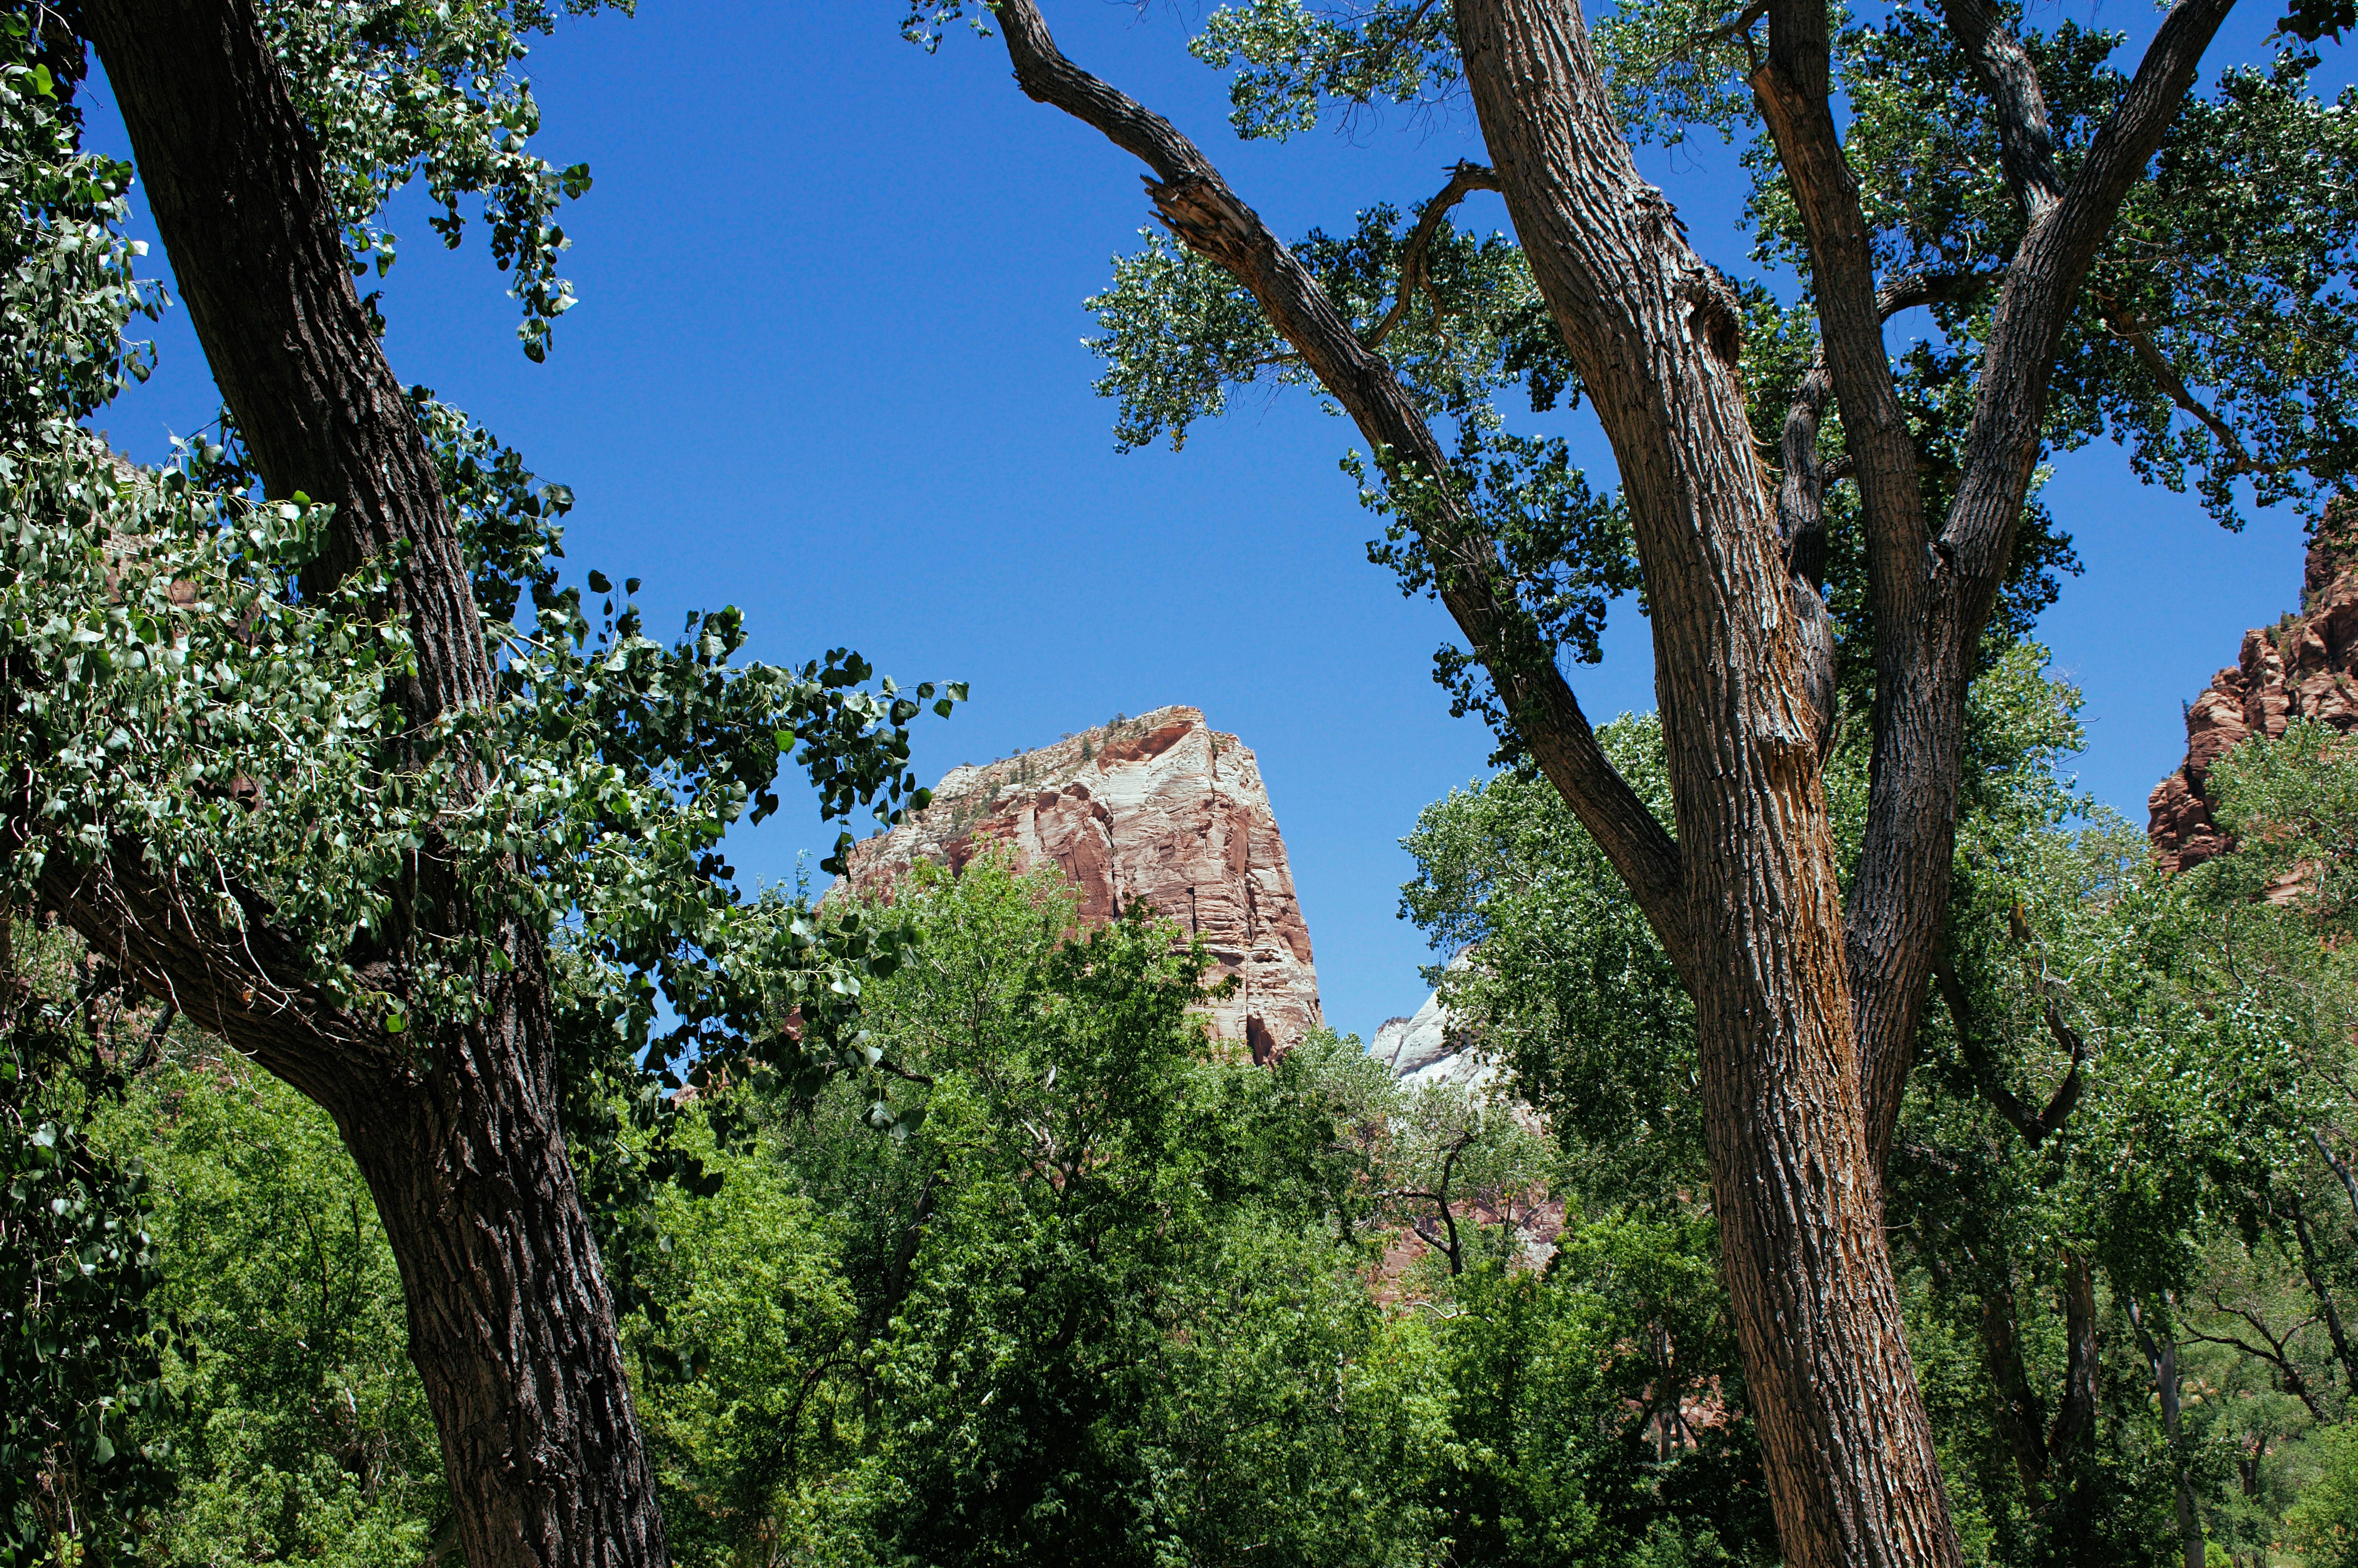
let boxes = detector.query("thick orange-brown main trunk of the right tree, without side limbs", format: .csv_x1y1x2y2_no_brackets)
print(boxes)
1457,0,1960,1568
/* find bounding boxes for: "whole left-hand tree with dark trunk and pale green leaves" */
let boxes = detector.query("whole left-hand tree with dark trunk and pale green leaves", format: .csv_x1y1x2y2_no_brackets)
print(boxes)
0,0,962,1568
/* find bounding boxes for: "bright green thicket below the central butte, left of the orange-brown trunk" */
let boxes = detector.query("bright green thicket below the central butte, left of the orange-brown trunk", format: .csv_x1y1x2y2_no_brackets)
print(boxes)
35,861,1773,1563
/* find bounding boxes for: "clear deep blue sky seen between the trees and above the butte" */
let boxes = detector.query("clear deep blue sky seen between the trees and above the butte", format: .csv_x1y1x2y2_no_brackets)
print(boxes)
92,0,2344,1038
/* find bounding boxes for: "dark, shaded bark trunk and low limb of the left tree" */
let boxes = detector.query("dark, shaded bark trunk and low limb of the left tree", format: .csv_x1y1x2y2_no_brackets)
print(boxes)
64,0,665,1568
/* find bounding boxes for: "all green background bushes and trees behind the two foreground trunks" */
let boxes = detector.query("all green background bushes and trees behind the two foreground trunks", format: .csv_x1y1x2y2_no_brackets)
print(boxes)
12,665,2358,1566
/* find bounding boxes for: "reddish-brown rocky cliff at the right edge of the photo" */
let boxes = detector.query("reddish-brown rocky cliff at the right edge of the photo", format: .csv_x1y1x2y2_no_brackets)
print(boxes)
2146,502,2358,870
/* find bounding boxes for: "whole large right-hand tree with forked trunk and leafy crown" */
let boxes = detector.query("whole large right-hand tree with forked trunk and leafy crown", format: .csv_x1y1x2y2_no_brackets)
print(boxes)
905,0,2351,1568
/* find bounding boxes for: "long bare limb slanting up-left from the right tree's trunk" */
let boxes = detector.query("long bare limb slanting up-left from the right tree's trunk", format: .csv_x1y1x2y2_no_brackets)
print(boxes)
993,0,1688,962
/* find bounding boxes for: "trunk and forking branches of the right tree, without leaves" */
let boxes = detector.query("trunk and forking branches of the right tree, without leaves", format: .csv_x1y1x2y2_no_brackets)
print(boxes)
971,0,2231,1568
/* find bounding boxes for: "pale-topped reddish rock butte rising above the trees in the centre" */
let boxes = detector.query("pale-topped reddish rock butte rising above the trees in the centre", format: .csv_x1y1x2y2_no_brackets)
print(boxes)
849,707,1323,1061
